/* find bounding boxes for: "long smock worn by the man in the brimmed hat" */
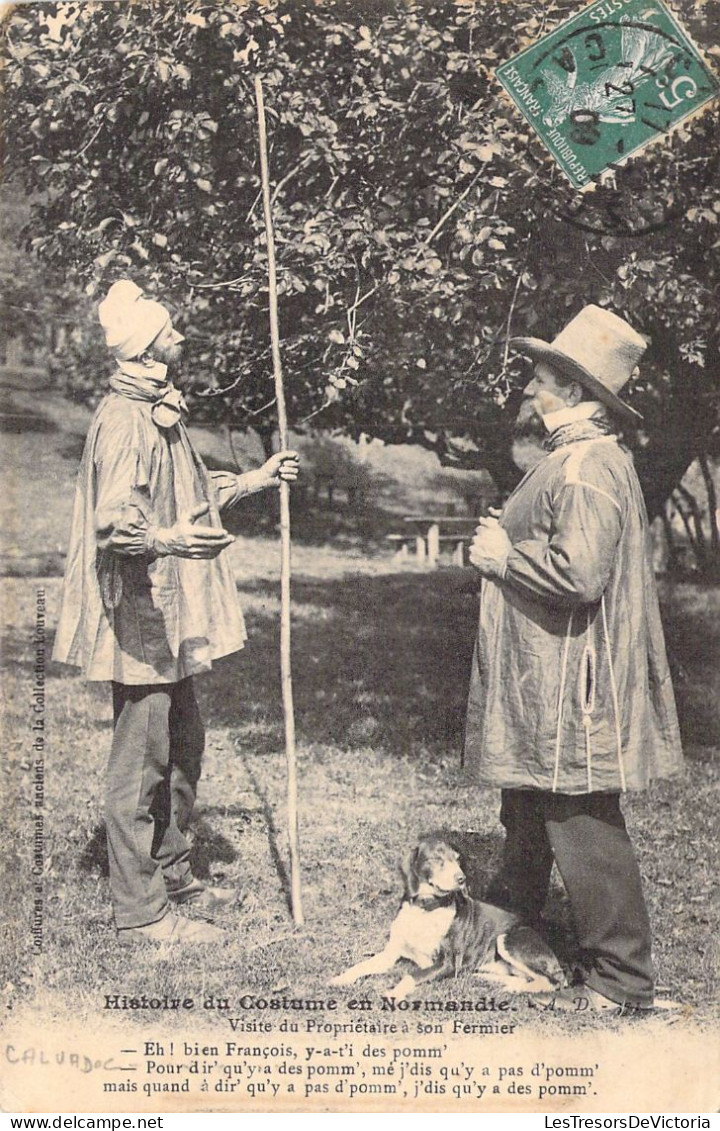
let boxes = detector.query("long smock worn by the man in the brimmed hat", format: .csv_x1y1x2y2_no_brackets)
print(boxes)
466,437,682,794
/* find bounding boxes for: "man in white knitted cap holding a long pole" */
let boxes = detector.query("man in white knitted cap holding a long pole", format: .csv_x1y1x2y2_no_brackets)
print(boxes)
54,279,298,943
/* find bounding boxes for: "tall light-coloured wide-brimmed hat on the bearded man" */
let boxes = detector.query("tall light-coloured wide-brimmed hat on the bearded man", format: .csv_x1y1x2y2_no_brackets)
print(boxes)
510,305,648,422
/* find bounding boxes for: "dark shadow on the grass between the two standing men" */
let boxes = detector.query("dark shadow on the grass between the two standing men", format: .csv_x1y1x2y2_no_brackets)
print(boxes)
201,570,477,760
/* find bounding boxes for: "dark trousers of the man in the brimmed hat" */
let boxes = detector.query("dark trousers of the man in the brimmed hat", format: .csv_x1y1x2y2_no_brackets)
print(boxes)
485,789,653,1004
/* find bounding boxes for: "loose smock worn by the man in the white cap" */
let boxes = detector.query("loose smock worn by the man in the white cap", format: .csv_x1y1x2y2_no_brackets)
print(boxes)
53,392,246,684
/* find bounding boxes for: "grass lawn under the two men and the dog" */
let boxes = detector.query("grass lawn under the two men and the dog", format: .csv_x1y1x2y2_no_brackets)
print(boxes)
0,384,720,1110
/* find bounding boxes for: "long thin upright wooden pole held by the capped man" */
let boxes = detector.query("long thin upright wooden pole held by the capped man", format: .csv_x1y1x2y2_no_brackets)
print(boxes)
255,75,304,926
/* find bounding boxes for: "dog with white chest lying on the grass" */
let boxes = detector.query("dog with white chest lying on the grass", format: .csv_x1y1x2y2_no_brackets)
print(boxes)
330,834,566,1001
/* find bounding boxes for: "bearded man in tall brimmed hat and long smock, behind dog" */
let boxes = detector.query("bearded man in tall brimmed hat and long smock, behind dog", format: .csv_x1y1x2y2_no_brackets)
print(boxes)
466,305,682,1011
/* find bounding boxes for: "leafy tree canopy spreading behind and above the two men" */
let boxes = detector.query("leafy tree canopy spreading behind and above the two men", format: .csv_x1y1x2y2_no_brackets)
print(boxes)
5,0,720,512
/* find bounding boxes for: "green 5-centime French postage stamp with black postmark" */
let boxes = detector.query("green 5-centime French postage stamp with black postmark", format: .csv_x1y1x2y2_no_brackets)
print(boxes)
496,0,719,189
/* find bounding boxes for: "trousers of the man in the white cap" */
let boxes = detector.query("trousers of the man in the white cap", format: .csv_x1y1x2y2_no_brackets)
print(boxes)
105,679,205,927
